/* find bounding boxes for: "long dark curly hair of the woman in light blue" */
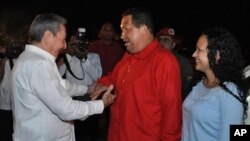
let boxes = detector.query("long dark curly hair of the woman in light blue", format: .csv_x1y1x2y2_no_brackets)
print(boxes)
202,27,247,121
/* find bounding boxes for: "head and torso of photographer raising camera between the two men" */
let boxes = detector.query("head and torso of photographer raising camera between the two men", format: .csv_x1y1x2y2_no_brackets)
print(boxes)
59,28,102,85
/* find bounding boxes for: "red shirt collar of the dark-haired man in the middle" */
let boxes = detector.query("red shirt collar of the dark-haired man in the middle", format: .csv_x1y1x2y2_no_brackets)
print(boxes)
130,39,159,59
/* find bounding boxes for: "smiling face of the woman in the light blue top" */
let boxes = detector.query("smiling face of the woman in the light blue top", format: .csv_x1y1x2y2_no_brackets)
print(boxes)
192,35,211,72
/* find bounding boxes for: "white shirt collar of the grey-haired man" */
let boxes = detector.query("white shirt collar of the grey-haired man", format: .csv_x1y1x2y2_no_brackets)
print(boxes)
25,45,56,62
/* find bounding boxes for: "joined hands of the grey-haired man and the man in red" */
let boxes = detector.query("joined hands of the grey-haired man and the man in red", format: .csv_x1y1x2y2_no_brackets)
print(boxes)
88,83,116,107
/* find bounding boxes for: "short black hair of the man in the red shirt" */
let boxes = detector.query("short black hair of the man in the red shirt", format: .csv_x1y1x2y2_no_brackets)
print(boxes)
122,7,154,34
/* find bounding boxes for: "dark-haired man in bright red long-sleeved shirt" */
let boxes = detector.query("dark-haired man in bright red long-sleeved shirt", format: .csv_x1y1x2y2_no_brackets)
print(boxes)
92,8,182,141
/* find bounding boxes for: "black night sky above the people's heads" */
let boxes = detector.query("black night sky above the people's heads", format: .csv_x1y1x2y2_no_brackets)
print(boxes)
0,0,250,60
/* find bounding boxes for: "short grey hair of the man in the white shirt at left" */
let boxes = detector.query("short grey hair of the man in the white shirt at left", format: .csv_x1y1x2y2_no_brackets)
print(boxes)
28,13,67,42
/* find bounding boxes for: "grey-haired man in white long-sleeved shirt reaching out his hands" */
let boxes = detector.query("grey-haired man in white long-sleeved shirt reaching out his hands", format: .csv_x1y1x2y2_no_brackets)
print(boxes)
12,13,115,141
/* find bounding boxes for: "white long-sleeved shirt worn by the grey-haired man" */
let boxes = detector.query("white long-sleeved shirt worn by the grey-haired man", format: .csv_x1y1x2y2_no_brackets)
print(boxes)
12,45,104,141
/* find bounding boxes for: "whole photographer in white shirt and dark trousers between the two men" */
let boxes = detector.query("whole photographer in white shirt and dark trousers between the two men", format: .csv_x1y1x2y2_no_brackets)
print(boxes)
59,28,102,141
